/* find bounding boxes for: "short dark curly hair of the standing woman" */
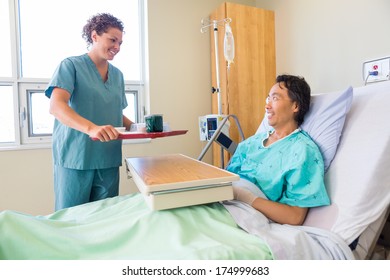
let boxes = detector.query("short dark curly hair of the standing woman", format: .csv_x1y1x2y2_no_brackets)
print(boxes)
82,13,124,47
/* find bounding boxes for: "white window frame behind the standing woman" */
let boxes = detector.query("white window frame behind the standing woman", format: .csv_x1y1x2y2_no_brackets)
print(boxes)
0,0,147,151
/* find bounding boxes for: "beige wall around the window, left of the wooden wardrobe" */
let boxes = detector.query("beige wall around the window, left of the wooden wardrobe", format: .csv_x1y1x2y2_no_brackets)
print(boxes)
0,0,256,215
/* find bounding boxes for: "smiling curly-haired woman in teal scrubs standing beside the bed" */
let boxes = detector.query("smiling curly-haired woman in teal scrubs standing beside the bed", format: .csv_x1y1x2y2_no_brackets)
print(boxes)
45,13,132,210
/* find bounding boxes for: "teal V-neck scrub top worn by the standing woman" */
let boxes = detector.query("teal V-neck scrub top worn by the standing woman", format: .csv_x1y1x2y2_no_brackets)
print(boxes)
45,54,127,170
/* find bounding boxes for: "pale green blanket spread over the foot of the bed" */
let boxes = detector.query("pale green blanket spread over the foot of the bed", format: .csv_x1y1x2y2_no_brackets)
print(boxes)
0,194,272,260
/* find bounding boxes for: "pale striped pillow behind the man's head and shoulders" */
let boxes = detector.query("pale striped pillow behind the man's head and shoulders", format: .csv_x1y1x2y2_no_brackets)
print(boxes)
256,87,353,172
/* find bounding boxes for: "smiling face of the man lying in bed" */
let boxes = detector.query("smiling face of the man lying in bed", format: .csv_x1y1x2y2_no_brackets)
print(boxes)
265,83,299,129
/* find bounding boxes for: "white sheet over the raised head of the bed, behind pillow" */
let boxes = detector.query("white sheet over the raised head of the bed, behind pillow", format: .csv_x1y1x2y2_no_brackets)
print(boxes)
304,81,390,244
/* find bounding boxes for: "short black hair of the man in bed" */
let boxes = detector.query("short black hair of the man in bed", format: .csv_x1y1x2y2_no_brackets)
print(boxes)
276,75,311,126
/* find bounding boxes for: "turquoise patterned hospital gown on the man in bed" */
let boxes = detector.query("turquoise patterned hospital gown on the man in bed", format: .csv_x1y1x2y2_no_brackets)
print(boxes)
227,129,330,207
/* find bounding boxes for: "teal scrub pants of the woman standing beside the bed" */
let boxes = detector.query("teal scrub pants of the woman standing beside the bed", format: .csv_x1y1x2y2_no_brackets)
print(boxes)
54,165,119,211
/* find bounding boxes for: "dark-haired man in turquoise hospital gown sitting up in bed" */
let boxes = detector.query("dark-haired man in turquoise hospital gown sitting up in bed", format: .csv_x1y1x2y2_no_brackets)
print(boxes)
227,75,330,225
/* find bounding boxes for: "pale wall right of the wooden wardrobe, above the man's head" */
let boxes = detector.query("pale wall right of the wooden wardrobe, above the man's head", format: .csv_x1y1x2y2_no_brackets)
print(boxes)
256,0,390,92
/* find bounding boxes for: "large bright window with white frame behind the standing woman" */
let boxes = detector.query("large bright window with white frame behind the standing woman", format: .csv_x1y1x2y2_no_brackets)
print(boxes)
0,0,146,147
